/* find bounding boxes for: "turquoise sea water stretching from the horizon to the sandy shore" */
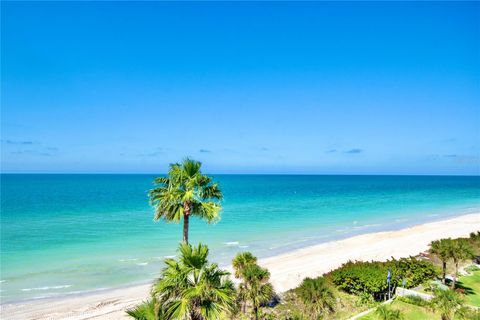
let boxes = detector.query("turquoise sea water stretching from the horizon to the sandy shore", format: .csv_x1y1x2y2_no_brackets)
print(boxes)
0,174,480,303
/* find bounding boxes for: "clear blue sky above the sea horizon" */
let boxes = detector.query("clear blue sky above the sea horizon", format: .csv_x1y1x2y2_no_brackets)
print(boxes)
1,2,480,175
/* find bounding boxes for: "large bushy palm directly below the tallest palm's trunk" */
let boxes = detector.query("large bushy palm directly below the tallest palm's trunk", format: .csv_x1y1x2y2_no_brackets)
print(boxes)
152,243,235,320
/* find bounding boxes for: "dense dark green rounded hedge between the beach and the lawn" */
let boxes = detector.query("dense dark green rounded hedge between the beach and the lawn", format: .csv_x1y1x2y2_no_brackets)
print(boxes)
328,257,437,298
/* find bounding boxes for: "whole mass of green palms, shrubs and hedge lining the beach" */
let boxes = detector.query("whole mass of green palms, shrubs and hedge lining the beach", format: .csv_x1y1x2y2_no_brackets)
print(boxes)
135,159,480,320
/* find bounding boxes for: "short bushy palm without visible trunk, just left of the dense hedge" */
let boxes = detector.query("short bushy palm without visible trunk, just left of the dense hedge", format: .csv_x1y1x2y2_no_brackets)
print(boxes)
295,277,336,319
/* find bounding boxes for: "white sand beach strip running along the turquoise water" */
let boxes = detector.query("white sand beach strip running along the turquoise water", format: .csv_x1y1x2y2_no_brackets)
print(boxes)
1,213,480,320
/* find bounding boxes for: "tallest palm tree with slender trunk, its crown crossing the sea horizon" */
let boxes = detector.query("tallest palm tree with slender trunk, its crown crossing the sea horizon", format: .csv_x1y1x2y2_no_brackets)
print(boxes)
149,158,222,243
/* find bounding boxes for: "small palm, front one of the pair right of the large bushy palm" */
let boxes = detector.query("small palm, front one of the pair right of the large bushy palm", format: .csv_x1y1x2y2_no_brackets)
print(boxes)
239,264,274,320
